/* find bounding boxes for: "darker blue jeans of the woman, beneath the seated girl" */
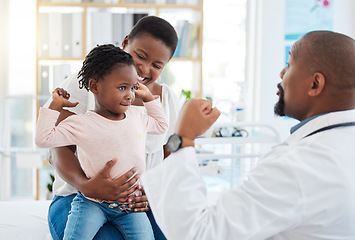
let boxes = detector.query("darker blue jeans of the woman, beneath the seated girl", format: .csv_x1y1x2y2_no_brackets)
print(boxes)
48,194,166,240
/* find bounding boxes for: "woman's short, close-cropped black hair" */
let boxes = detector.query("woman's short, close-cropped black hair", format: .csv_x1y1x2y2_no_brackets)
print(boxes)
129,16,178,58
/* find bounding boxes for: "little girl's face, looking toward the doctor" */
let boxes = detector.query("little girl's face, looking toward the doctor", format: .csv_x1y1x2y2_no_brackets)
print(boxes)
93,65,137,120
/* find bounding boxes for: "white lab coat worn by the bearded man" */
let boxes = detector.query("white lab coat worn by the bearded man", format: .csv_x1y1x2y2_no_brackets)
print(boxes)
142,110,355,240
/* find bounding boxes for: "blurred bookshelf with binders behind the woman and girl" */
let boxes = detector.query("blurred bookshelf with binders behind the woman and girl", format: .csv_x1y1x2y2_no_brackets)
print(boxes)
36,0,203,105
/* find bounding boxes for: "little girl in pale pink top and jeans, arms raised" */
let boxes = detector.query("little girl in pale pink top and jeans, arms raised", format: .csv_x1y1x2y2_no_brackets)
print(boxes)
36,44,168,239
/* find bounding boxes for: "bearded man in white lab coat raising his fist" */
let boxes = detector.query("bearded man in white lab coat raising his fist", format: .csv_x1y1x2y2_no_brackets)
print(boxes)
142,31,355,240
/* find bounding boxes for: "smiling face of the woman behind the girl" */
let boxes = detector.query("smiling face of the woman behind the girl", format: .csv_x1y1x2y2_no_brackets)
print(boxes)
122,34,172,86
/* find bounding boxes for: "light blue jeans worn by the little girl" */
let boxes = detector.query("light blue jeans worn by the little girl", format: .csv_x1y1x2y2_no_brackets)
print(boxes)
64,193,154,240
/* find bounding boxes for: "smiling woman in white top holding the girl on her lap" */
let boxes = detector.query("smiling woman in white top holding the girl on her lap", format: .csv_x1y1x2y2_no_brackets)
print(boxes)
48,16,180,239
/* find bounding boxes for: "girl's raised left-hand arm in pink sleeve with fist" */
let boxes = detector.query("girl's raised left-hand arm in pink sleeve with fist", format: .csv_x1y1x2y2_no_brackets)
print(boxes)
35,88,80,148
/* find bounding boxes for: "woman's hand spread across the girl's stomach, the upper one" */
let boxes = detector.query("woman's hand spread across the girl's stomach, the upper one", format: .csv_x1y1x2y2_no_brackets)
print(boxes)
79,159,140,203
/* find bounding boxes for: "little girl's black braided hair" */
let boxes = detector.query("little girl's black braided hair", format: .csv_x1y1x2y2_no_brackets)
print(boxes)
78,44,134,91
